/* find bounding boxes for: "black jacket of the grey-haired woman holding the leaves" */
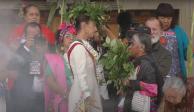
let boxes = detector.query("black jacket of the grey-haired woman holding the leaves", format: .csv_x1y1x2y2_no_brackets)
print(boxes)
124,55,163,112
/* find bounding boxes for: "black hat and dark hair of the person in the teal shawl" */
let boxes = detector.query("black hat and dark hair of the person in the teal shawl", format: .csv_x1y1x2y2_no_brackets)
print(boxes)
155,3,176,28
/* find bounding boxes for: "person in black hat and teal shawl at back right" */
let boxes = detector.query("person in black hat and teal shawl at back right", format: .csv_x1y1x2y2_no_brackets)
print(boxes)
156,3,189,80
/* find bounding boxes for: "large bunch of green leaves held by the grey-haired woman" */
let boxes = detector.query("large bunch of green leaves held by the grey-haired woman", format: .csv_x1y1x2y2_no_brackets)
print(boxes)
100,38,134,89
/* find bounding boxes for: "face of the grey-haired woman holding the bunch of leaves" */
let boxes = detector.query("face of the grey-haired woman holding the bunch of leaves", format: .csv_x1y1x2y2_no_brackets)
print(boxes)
128,35,143,57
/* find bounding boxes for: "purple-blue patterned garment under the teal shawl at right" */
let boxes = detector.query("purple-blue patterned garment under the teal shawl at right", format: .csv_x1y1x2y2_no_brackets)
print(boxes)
163,31,181,76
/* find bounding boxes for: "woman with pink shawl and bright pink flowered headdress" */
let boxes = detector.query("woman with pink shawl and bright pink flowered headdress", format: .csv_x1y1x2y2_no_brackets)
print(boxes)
44,23,76,112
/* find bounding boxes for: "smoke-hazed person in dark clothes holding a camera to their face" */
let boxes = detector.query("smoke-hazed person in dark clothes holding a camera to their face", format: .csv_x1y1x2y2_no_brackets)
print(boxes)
7,22,47,112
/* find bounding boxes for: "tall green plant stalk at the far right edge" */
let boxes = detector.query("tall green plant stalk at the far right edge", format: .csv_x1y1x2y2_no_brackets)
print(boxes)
187,11,194,76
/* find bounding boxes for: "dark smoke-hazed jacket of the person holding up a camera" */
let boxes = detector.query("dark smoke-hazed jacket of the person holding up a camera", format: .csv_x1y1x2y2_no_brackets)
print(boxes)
7,45,44,112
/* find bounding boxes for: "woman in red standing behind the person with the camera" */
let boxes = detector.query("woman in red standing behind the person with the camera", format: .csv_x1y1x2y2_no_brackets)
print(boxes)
8,4,55,50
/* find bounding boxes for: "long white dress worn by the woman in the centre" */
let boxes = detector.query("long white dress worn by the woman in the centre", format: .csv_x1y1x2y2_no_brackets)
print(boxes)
68,40,102,112
